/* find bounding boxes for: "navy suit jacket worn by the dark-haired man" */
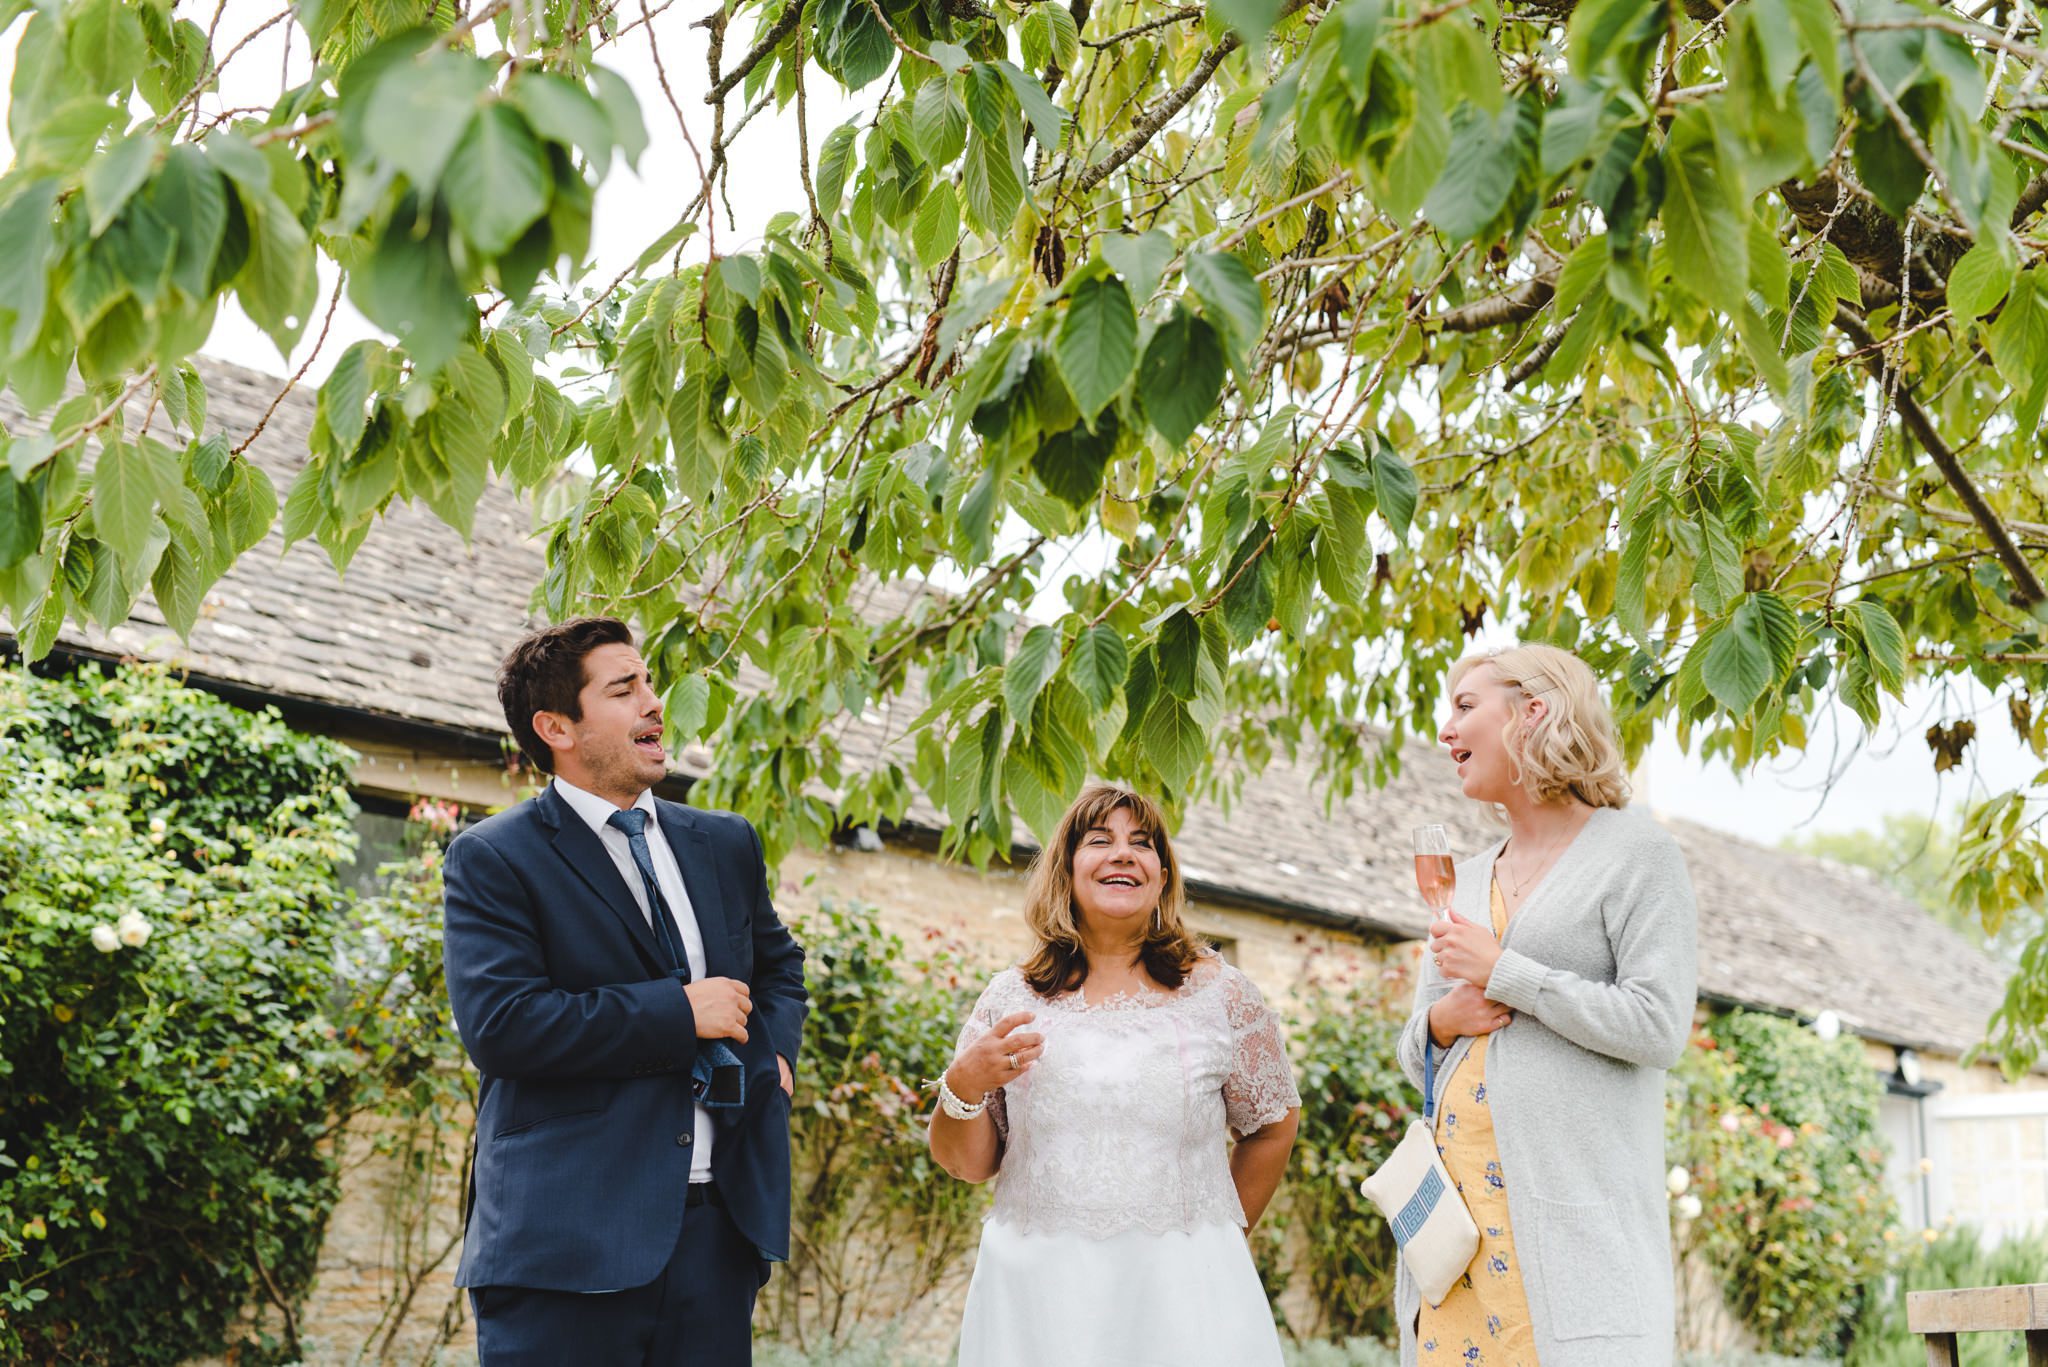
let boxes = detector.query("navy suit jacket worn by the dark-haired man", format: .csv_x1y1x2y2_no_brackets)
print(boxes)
442,785,807,1291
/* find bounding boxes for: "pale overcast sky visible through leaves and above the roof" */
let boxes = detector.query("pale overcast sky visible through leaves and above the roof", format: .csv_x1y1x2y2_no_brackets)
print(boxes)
0,0,2034,844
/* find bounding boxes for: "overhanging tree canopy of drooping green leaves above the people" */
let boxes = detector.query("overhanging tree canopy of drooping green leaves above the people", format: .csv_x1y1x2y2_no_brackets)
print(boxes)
0,0,2048,1068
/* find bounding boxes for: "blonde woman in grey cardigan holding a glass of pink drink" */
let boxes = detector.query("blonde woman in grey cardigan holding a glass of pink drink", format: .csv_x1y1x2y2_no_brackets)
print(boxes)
1395,646,1698,1367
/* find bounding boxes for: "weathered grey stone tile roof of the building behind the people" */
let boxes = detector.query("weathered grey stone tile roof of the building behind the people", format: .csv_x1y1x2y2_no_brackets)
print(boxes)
0,361,2005,1053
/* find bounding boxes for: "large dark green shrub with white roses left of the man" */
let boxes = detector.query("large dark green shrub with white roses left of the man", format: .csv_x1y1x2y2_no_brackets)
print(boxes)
0,668,453,1367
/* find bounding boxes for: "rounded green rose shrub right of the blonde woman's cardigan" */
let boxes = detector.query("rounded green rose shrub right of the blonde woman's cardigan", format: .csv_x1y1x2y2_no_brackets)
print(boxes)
1667,1010,1894,1355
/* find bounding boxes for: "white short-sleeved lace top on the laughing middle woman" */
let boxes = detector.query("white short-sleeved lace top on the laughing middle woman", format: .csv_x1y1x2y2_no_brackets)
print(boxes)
958,953,1300,1238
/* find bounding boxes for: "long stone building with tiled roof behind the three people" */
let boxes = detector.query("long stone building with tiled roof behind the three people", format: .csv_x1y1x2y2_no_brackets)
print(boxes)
0,363,2048,1361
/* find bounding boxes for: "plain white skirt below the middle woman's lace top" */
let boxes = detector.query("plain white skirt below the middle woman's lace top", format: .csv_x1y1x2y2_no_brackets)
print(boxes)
961,1219,1280,1367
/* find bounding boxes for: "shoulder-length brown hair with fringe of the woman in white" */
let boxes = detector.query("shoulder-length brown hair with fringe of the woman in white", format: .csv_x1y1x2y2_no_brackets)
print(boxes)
1022,783,1202,996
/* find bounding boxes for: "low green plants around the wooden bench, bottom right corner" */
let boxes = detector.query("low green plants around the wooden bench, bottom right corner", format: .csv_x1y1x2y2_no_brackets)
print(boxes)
1845,1226,2048,1367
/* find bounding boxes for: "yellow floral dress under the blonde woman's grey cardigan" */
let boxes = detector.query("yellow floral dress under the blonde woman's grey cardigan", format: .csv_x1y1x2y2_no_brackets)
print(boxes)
1415,881,1538,1367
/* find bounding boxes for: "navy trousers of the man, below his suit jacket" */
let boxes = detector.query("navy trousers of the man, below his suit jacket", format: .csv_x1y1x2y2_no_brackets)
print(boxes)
469,1191,766,1367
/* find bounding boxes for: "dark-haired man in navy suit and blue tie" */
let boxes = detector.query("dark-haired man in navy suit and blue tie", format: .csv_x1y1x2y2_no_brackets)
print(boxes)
444,617,807,1367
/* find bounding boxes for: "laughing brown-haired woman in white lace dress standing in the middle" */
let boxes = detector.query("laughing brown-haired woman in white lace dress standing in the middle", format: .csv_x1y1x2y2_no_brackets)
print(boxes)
932,785,1300,1367
